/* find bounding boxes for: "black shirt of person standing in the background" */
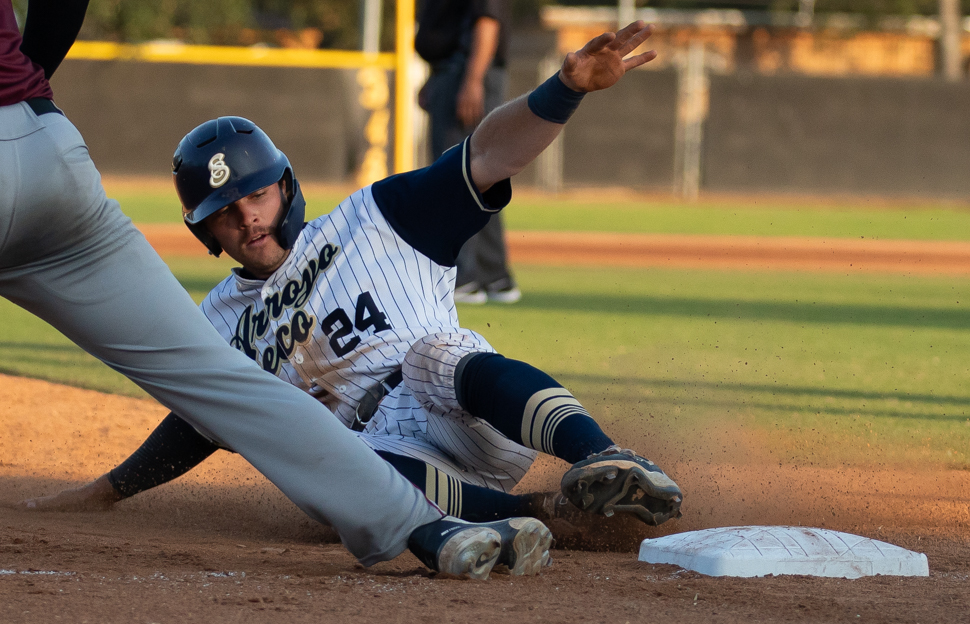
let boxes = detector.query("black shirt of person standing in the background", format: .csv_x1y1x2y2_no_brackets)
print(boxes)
414,0,508,67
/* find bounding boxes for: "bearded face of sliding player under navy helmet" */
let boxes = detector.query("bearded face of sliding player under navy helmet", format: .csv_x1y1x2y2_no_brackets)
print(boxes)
203,184,290,279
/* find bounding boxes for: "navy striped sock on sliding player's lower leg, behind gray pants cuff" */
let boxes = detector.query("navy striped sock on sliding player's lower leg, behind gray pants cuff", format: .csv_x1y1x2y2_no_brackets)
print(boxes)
377,451,532,522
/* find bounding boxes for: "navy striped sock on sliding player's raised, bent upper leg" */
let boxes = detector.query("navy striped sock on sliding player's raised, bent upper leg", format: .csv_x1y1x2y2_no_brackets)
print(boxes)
455,353,613,464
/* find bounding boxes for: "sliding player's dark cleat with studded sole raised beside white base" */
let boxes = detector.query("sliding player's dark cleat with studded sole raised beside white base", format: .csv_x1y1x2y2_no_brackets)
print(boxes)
562,446,683,526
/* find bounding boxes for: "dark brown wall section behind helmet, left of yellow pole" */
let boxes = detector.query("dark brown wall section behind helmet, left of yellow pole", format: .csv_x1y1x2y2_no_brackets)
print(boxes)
53,60,365,182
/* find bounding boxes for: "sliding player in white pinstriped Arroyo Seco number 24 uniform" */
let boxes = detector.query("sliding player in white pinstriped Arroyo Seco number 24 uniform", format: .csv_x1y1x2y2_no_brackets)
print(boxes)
17,22,682,544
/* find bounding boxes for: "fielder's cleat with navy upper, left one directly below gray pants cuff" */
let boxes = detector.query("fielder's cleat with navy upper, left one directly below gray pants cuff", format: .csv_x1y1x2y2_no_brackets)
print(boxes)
408,516,502,580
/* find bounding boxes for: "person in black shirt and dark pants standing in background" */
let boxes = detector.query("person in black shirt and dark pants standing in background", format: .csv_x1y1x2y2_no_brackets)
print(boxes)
414,0,522,304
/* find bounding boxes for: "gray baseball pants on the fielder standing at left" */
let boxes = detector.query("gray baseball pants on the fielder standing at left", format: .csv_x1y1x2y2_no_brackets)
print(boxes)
0,103,442,565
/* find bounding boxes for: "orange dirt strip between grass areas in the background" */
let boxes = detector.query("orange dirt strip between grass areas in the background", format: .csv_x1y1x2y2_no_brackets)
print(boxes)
139,224,970,274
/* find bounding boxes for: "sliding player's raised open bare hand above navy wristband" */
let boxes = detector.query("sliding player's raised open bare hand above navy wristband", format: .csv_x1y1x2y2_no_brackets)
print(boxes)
559,20,657,93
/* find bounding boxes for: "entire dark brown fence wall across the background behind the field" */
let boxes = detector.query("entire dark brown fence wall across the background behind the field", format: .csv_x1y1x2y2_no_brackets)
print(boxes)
54,61,970,197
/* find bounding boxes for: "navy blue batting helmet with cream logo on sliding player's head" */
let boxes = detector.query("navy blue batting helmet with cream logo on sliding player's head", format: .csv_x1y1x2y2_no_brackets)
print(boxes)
172,117,306,256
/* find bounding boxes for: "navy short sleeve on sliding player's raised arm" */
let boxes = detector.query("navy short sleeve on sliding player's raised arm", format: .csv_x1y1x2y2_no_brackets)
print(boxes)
372,139,512,266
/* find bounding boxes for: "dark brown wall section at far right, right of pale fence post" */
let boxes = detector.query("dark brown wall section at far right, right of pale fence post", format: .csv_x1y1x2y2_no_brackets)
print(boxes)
702,74,970,196
